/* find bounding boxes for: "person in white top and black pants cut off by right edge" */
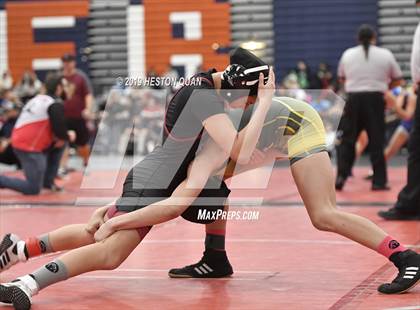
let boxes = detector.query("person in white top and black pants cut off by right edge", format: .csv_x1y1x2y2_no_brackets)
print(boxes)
378,0,420,220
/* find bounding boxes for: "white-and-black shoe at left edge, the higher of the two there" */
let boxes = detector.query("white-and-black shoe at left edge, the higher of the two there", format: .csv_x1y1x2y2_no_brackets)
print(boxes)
0,234,28,272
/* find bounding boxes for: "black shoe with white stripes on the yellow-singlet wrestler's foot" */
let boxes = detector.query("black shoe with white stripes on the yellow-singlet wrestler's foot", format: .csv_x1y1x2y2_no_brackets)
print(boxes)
378,250,420,294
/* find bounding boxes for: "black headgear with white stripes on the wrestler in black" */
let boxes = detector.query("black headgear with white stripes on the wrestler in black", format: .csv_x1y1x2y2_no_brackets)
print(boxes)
221,47,269,102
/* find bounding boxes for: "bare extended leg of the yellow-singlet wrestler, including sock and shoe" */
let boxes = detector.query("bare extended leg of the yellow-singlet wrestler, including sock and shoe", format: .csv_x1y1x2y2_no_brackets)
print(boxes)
292,152,420,294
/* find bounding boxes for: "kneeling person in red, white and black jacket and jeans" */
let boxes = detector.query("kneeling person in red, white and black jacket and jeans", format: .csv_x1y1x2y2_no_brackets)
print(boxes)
0,75,73,195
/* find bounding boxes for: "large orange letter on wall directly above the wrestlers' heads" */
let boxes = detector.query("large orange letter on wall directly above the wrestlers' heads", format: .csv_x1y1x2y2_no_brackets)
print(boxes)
144,0,230,73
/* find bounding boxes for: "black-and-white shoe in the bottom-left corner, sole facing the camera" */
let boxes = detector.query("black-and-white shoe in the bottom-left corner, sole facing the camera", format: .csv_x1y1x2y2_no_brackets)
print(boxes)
0,281,32,310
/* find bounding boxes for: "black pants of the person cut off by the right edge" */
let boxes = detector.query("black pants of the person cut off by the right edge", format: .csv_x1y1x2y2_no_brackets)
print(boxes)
396,91,420,214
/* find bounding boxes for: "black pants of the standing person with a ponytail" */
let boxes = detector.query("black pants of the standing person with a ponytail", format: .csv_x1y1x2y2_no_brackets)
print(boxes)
337,92,387,186
